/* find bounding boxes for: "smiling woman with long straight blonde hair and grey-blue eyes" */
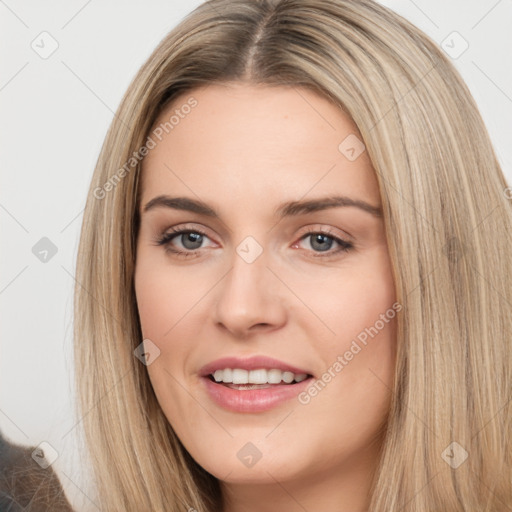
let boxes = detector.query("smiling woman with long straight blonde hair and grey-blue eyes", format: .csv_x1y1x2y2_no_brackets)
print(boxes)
75,0,512,512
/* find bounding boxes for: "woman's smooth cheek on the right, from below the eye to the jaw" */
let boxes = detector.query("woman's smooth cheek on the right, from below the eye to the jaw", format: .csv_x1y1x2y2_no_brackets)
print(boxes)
294,251,400,428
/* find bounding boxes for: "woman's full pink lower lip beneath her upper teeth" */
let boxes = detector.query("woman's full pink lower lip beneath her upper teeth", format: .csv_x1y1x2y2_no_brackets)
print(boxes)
202,377,312,412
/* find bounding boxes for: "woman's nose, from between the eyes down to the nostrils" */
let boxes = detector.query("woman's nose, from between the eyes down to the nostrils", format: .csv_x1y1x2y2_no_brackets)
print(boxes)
214,246,287,338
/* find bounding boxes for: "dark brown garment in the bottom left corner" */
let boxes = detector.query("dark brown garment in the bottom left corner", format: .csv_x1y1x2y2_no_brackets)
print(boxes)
0,434,73,512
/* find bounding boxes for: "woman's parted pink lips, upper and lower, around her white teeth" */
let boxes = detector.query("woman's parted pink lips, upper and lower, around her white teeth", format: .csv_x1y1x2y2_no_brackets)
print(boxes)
199,356,312,412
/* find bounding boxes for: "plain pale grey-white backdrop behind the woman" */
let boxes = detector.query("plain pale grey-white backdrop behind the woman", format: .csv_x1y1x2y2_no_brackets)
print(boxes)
0,0,512,511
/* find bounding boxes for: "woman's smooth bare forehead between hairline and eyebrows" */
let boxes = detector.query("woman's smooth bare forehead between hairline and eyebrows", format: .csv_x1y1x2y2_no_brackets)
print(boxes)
142,83,380,208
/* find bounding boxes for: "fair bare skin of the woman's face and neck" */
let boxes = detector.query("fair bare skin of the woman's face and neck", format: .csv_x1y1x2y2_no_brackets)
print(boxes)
135,83,396,512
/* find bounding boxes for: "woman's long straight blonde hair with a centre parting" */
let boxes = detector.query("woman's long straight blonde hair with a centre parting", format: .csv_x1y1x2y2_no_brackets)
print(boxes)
75,0,512,512
